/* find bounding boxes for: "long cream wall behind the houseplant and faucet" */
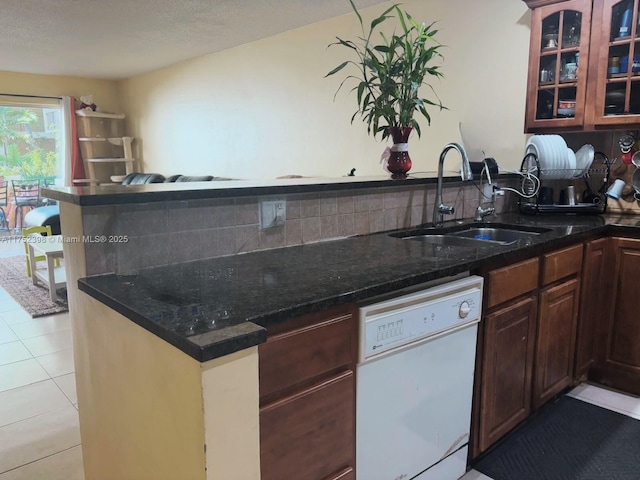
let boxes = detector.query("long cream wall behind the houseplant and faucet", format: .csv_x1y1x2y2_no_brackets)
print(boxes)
120,0,530,178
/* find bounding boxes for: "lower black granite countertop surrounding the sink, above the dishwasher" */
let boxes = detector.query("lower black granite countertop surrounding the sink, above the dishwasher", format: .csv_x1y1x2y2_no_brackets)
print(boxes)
78,215,640,362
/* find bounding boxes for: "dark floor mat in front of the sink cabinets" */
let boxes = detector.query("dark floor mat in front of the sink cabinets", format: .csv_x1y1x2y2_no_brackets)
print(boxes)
473,396,640,480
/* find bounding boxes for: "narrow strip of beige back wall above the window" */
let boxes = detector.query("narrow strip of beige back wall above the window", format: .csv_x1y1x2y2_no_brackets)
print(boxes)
0,71,121,111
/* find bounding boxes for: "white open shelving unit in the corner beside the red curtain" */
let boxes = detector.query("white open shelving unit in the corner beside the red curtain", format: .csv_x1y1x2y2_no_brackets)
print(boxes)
76,110,135,185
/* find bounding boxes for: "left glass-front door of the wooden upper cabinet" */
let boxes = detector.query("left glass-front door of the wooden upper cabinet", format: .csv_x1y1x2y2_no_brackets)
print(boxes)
525,0,592,132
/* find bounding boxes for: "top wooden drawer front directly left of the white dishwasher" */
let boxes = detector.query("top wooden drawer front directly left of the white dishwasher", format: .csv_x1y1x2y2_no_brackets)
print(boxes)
258,313,357,400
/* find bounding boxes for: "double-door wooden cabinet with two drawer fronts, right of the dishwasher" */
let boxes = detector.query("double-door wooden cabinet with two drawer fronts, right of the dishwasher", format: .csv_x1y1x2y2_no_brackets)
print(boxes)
470,244,583,458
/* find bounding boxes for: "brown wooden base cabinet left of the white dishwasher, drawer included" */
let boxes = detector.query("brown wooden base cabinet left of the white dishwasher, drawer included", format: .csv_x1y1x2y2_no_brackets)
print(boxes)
258,306,357,480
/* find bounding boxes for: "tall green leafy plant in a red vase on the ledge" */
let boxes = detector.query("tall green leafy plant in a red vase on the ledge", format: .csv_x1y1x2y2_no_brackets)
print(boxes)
325,0,445,178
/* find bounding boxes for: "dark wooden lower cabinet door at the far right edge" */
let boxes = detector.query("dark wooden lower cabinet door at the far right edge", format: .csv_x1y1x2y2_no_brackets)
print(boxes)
589,238,640,395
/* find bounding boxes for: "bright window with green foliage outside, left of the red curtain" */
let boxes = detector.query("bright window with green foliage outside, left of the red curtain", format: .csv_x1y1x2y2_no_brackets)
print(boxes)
0,95,66,185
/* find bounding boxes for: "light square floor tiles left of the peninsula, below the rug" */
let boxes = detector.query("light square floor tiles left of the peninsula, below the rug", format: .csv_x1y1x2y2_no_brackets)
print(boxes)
0,284,84,480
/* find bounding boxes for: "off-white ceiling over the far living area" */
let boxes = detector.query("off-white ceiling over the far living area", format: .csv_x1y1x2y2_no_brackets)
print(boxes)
0,0,383,79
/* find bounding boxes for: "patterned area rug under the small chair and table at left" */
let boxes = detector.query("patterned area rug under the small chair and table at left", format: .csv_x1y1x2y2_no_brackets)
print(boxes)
0,255,69,318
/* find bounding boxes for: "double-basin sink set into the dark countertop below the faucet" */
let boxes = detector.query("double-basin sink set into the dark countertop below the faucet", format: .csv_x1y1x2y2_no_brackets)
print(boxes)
391,223,552,248
